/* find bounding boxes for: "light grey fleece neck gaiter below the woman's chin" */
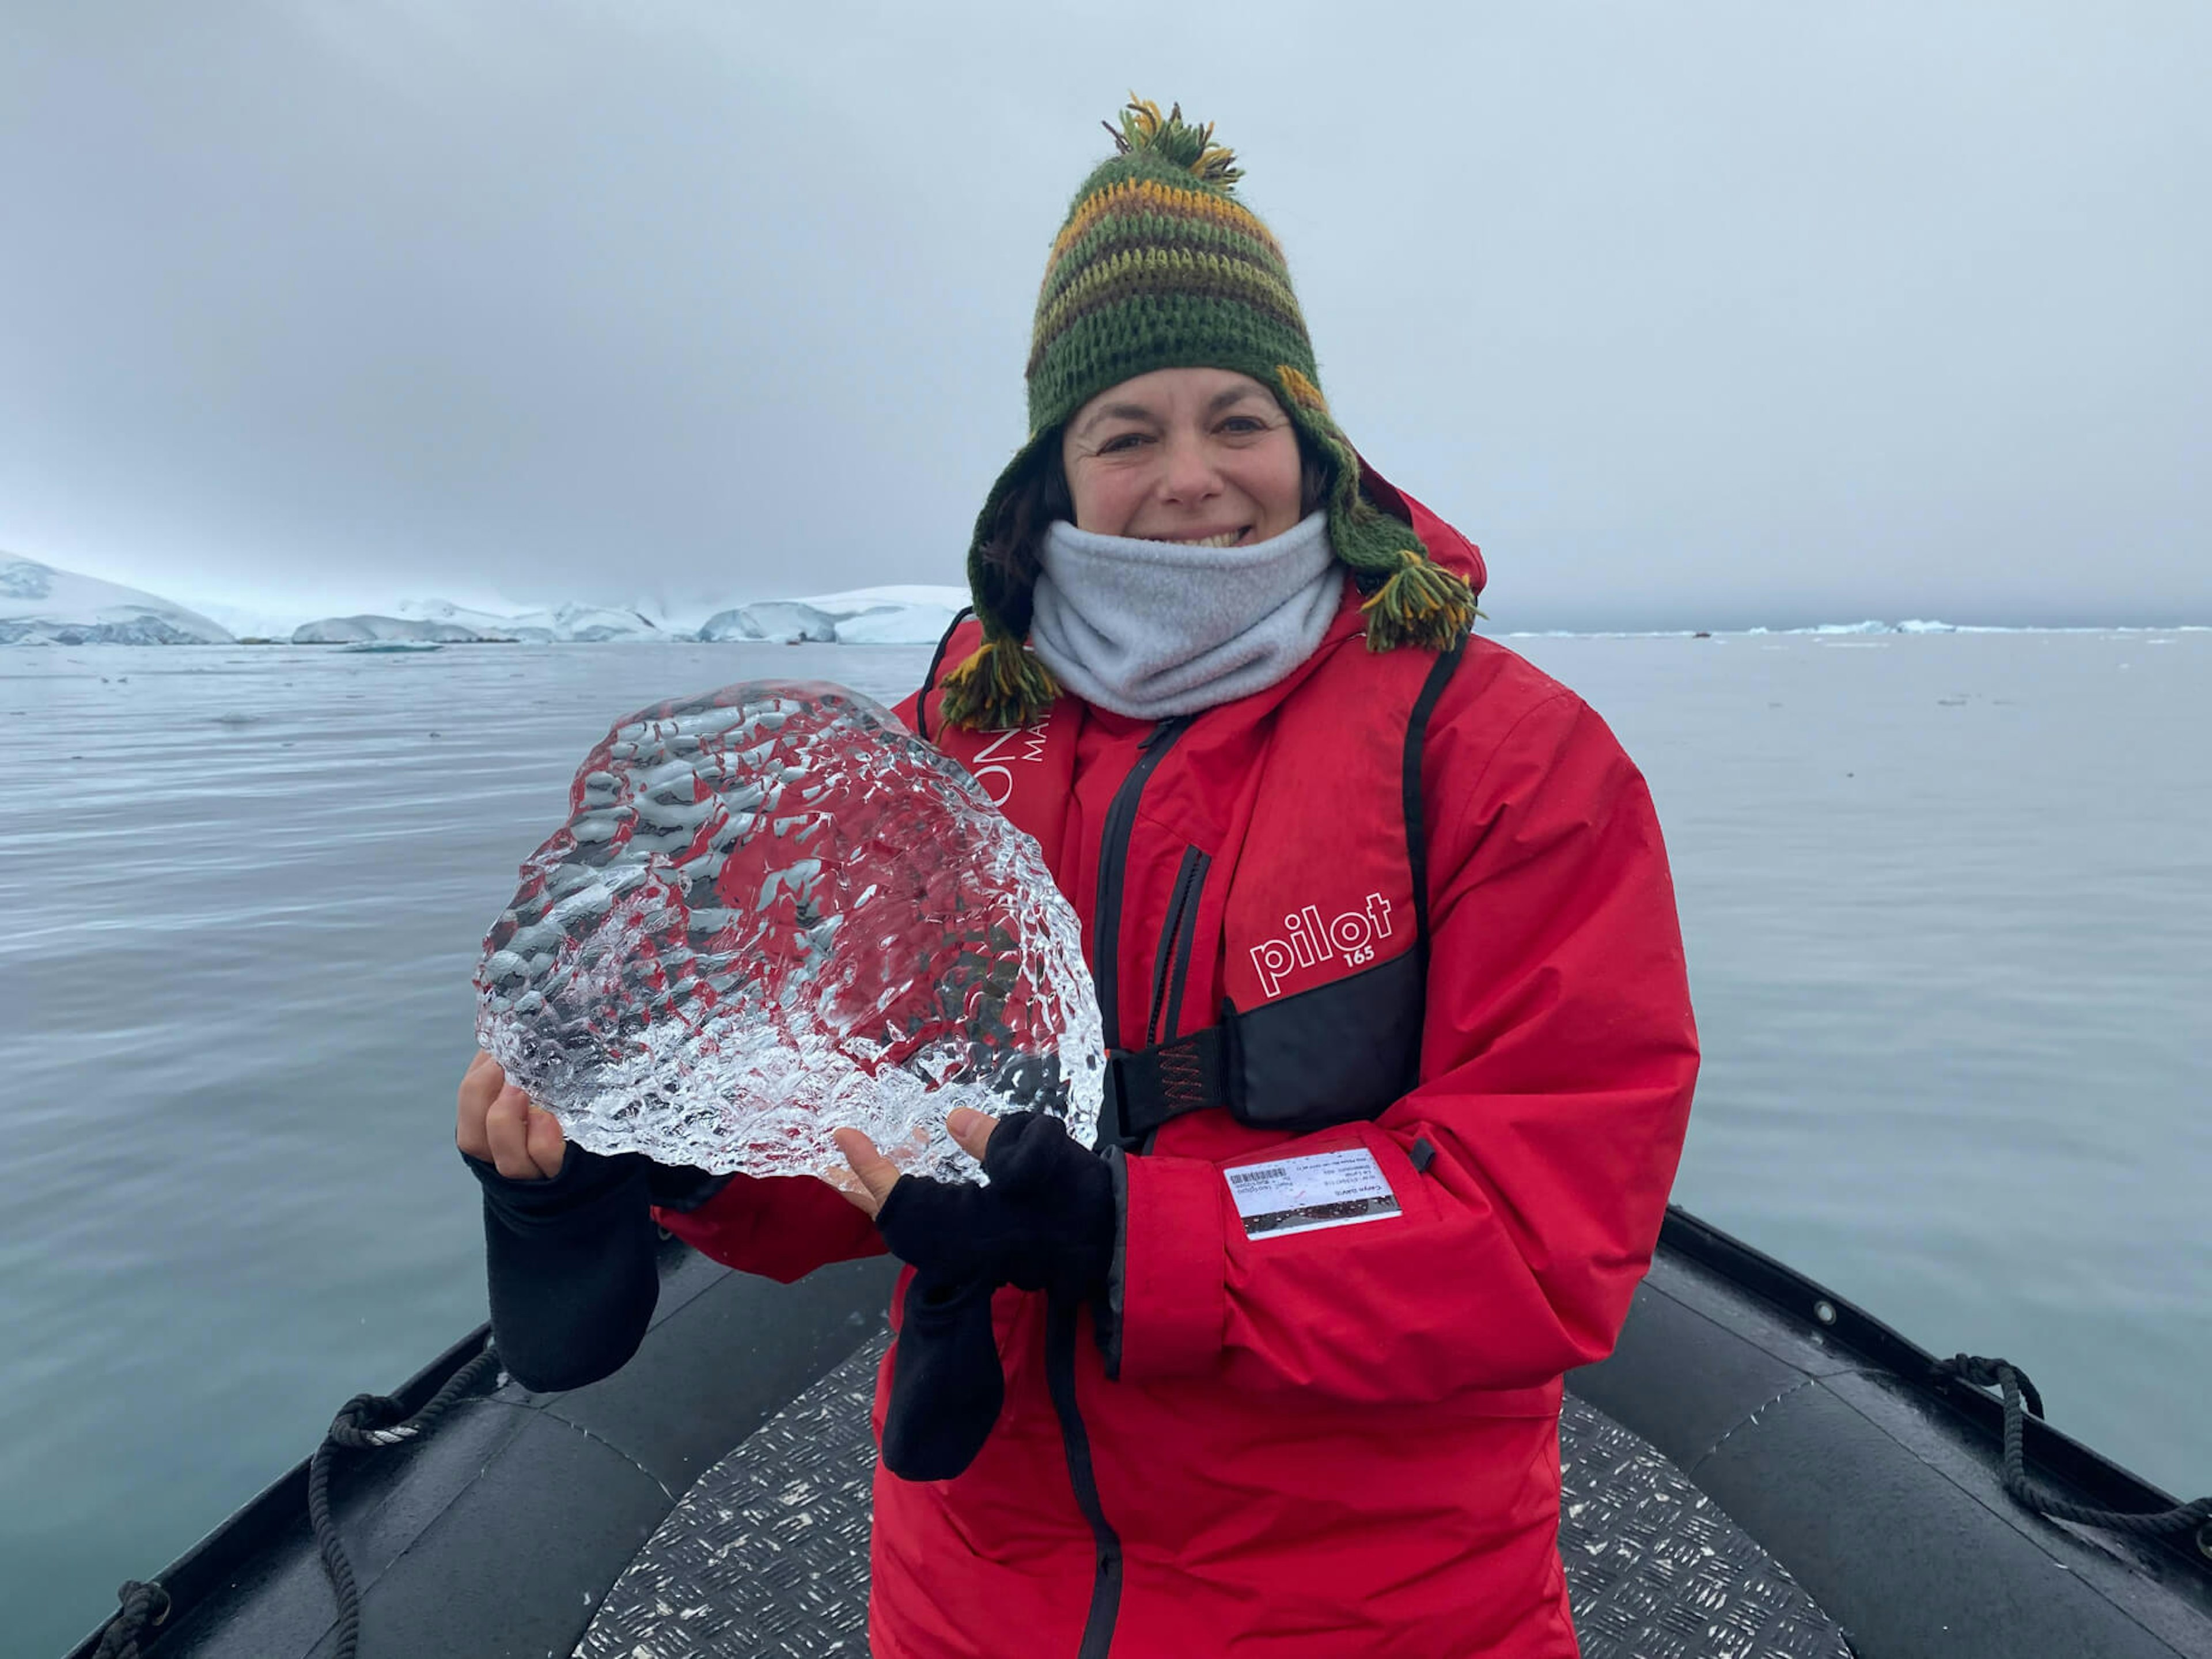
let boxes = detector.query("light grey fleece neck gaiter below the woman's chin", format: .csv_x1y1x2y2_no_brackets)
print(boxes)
1029,511,1345,719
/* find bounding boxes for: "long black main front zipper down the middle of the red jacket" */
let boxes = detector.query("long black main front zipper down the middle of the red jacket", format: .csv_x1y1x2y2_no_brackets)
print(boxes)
1044,714,1190,1659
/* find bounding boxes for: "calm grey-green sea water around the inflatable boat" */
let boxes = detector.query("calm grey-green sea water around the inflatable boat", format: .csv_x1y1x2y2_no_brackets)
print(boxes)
0,632,2212,1654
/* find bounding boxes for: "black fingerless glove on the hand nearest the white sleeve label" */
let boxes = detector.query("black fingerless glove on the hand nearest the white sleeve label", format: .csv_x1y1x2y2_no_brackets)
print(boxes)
876,1113,1119,1480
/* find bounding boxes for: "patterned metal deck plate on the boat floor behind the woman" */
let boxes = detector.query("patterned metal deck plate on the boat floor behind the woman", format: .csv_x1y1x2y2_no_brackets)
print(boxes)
575,1336,1849,1659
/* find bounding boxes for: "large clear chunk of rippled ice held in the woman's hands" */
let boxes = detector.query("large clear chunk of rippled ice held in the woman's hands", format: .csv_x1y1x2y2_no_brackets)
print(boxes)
476,681,1104,1175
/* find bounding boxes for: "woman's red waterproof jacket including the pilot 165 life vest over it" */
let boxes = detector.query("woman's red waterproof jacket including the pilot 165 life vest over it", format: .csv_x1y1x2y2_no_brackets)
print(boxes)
661,478,1696,1659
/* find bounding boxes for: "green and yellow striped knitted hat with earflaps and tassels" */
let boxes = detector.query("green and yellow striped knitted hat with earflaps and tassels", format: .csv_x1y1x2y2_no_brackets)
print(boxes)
945,97,1475,730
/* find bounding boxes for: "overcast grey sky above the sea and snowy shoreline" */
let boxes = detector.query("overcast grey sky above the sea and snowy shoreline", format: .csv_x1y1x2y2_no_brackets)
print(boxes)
0,0,2212,628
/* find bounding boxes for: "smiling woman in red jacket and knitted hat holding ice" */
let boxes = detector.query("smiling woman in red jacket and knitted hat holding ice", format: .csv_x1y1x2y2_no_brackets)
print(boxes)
460,104,1696,1659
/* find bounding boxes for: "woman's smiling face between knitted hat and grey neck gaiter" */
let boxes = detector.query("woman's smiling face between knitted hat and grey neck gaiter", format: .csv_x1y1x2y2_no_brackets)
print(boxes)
1059,369,1305,546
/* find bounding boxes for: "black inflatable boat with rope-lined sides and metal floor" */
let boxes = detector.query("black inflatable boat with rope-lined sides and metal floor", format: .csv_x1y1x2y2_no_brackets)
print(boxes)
71,1210,2212,1659
